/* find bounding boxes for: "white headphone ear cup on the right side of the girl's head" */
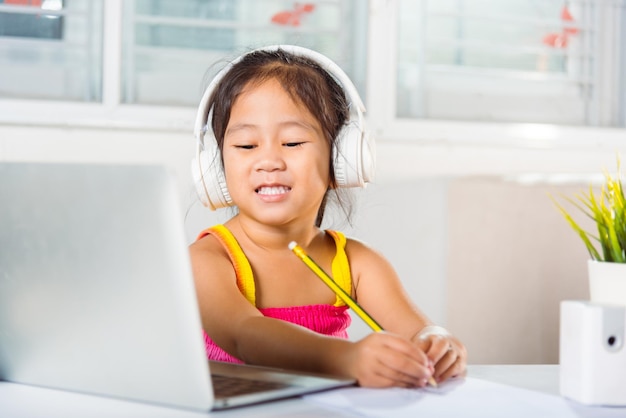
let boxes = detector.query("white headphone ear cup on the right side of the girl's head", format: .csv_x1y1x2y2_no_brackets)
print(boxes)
333,122,375,187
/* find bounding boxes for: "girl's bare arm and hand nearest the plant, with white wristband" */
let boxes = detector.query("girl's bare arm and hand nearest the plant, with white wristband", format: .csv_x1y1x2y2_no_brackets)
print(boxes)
346,240,467,381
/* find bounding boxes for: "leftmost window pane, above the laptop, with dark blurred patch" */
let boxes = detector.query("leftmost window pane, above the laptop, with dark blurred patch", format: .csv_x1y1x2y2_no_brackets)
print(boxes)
0,0,102,102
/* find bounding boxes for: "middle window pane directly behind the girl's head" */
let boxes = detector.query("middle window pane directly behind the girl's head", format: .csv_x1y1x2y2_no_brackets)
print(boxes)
122,0,367,106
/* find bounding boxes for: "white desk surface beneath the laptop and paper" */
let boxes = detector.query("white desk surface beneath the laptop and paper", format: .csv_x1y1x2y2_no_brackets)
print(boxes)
0,365,608,418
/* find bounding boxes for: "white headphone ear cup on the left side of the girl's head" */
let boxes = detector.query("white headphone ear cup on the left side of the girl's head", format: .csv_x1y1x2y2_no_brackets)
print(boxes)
191,135,233,210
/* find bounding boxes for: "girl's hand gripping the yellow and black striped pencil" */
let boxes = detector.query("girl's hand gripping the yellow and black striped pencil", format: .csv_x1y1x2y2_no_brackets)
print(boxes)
344,332,434,388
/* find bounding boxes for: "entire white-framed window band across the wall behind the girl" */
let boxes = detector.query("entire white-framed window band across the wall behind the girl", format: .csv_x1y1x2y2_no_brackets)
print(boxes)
0,0,626,134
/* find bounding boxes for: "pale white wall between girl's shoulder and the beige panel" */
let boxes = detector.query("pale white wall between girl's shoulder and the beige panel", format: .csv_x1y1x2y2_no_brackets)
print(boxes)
347,178,448,339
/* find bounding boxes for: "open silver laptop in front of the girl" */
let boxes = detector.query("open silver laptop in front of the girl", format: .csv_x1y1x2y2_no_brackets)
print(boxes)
0,163,353,410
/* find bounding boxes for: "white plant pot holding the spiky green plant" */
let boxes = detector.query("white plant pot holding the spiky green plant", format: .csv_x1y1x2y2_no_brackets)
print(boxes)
587,260,626,306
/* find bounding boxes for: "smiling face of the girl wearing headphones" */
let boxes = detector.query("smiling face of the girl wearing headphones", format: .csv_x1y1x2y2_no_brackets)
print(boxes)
222,79,330,229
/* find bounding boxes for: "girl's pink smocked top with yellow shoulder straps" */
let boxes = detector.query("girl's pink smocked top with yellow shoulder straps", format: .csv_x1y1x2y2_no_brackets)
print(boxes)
198,225,352,363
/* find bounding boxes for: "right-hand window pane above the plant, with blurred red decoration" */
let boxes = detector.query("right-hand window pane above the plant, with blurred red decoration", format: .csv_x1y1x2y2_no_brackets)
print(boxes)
396,0,626,126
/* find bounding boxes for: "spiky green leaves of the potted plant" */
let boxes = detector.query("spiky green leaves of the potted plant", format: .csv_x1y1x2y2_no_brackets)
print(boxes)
551,158,626,263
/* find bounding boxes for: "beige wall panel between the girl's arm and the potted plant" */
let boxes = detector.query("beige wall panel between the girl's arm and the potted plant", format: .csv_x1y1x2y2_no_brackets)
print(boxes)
445,177,593,364
